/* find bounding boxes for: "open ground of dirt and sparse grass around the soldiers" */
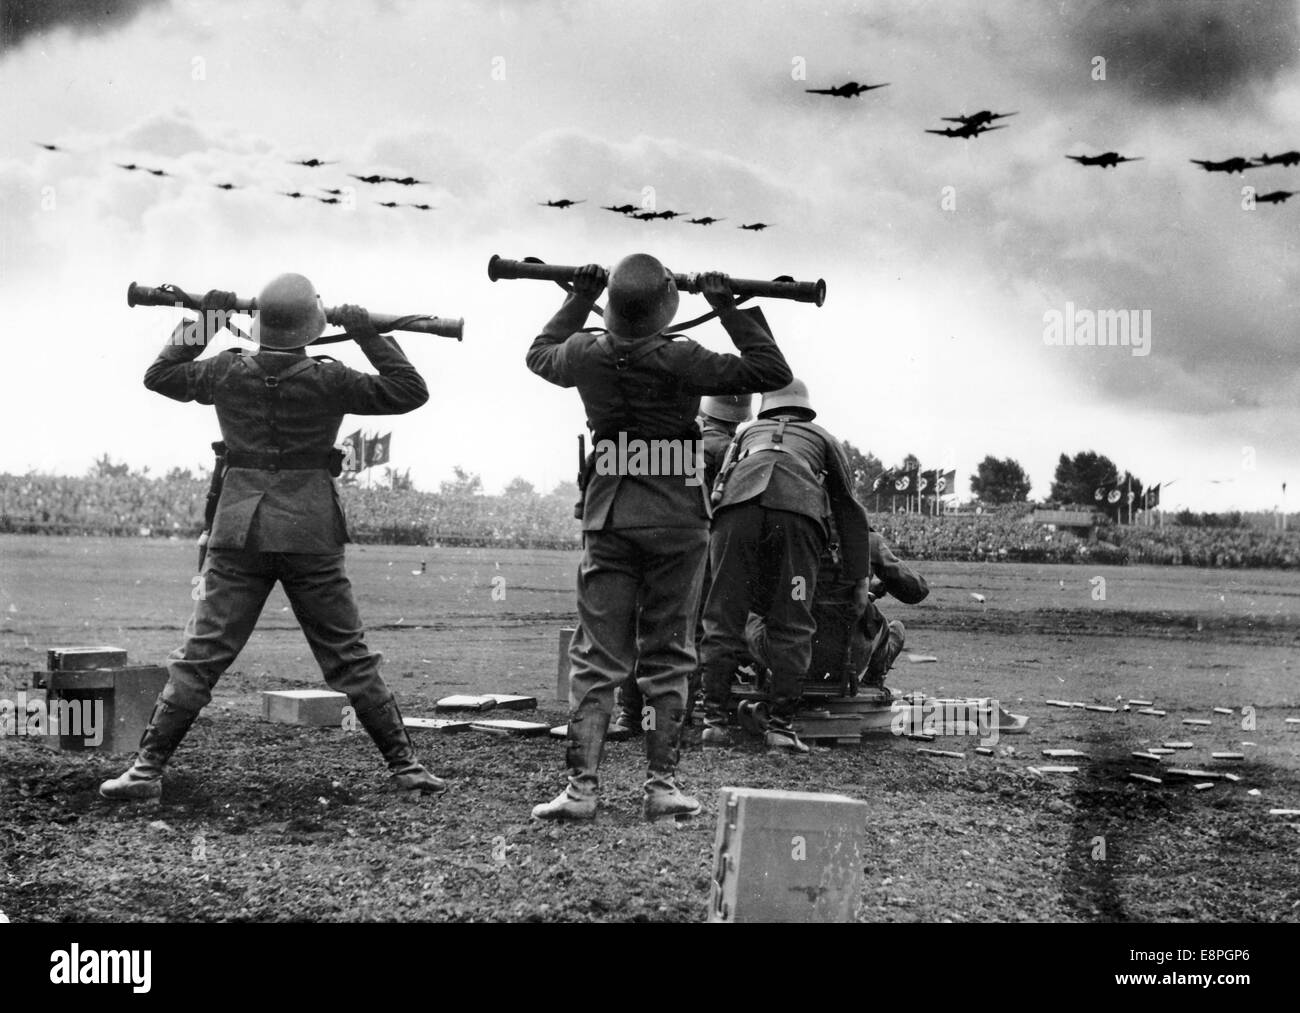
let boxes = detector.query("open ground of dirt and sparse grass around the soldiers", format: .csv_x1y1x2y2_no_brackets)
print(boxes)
0,536,1300,922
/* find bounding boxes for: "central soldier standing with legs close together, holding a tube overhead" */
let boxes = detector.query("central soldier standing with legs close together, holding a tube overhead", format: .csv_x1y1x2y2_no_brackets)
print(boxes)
528,254,790,819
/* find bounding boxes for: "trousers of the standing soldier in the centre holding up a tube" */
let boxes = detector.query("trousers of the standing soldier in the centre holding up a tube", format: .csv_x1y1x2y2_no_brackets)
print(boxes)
569,528,709,720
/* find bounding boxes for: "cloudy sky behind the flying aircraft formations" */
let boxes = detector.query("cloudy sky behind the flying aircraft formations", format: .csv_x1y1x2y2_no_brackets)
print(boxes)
0,0,1300,510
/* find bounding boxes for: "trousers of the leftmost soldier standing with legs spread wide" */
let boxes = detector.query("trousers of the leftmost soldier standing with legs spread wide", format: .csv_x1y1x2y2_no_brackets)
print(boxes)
163,549,391,714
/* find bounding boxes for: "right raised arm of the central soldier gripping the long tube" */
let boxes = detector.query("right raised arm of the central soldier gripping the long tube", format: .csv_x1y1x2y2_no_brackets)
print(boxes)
684,272,794,394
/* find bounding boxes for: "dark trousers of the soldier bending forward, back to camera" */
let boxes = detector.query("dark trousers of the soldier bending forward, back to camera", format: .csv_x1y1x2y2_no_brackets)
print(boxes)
701,502,826,718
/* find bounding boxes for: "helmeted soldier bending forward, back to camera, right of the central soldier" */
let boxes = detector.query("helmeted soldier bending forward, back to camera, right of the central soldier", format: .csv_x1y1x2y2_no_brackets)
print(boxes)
701,380,871,753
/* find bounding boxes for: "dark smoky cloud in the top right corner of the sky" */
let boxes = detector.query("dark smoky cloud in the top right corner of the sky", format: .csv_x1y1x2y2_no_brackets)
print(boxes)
1066,0,1300,105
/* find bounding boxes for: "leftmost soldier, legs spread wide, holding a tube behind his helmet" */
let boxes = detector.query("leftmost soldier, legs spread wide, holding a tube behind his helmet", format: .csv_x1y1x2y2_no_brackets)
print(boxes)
100,274,446,800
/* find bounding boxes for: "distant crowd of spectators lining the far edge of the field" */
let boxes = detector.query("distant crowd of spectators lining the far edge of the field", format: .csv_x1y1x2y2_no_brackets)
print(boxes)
0,473,1300,568
